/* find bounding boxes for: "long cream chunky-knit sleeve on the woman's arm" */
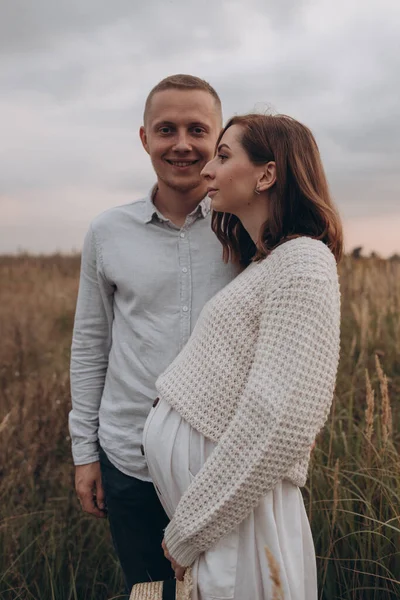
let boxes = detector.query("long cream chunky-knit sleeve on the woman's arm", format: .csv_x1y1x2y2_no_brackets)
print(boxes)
165,270,340,566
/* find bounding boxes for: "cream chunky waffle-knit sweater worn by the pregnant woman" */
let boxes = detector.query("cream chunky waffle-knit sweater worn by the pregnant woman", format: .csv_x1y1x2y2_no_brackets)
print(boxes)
156,237,340,566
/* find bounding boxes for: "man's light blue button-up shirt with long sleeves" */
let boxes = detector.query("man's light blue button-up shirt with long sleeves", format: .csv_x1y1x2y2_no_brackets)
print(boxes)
69,188,238,481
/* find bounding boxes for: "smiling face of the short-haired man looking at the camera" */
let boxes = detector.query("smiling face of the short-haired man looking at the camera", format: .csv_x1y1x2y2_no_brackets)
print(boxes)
140,90,222,192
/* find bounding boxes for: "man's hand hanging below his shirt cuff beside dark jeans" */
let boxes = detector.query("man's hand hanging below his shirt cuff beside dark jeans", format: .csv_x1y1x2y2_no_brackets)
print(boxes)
75,461,106,519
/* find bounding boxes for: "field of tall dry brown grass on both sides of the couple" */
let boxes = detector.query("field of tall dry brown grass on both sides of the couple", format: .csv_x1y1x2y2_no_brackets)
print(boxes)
0,255,400,600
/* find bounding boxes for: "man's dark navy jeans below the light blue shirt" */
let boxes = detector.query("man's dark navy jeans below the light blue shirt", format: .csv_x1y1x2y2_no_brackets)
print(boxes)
100,448,175,591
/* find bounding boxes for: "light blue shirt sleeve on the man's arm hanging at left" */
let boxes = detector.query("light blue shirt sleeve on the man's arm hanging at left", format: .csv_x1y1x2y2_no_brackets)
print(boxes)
69,227,114,465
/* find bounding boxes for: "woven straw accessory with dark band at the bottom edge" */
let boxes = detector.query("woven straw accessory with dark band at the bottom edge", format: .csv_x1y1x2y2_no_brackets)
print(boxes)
129,568,193,600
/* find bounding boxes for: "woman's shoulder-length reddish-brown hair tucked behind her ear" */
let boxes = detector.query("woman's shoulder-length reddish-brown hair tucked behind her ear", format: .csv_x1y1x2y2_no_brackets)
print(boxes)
212,114,343,265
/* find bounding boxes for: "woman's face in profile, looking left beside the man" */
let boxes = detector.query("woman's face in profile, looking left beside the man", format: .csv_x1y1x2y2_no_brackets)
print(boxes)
201,125,262,217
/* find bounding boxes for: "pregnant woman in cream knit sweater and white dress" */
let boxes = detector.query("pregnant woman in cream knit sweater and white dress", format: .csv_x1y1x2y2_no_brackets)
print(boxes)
144,115,342,600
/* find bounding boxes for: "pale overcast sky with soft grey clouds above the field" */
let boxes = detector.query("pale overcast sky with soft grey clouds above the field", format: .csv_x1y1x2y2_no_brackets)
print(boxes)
0,0,400,255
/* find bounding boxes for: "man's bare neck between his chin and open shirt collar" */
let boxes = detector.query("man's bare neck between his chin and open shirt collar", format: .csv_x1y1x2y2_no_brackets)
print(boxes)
153,181,206,227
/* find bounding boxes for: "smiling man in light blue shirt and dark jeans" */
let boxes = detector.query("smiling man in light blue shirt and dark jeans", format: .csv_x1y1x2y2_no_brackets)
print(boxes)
69,75,237,589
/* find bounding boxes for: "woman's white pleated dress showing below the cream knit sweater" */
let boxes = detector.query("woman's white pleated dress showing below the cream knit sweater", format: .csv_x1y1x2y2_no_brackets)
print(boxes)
143,398,317,600
